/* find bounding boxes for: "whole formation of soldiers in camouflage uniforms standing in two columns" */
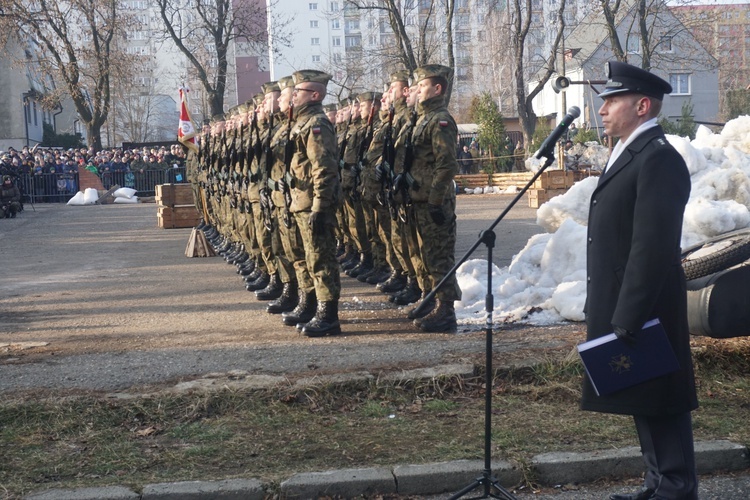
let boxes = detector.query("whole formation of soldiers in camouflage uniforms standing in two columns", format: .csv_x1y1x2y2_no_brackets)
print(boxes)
188,65,461,337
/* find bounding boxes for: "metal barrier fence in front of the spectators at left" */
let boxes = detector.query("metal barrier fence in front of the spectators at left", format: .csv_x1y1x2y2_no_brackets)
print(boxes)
16,168,187,203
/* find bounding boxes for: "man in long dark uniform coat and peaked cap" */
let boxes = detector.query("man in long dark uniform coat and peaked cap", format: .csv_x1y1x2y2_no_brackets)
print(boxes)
581,62,698,500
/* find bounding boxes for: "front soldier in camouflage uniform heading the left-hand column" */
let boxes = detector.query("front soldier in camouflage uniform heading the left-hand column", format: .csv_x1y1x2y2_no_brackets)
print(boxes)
291,70,341,337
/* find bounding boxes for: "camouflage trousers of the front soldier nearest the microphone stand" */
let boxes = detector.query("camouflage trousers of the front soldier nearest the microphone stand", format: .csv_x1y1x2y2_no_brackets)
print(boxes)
413,197,461,301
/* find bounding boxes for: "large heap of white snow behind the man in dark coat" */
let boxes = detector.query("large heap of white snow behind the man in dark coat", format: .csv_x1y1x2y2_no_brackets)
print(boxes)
456,116,750,326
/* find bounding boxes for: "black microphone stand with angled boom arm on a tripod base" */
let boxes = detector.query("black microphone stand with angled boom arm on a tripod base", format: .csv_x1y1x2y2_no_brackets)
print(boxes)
432,151,555,500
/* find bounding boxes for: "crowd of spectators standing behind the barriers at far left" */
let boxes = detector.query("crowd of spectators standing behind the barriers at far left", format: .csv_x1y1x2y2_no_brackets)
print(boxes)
0,145,185,201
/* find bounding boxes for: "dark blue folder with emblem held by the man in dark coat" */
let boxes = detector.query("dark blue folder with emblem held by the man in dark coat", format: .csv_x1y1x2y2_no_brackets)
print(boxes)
578,319,680,396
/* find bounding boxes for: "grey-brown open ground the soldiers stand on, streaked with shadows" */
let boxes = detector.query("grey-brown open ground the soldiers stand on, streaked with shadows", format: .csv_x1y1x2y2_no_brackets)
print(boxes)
0,195,583,392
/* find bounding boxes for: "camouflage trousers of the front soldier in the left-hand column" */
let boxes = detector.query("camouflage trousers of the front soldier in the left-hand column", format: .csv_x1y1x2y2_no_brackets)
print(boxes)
294,211,341,302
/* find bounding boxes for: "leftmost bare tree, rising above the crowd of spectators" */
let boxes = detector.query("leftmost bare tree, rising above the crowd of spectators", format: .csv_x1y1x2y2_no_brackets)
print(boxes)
0,0,132,149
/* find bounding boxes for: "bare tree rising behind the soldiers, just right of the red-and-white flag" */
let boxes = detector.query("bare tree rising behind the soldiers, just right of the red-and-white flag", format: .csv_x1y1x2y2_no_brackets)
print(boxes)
156,0,289,114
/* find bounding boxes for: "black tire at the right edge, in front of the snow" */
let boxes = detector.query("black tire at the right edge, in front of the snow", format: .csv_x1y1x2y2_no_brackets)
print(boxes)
682,229,750,281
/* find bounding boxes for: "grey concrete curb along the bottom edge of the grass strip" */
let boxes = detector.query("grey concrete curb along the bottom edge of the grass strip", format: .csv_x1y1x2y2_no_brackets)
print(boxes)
24,441,750,500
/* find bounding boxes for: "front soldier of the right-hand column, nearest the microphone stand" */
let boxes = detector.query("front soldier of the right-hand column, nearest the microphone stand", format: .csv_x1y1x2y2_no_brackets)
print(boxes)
409,64,461,332
